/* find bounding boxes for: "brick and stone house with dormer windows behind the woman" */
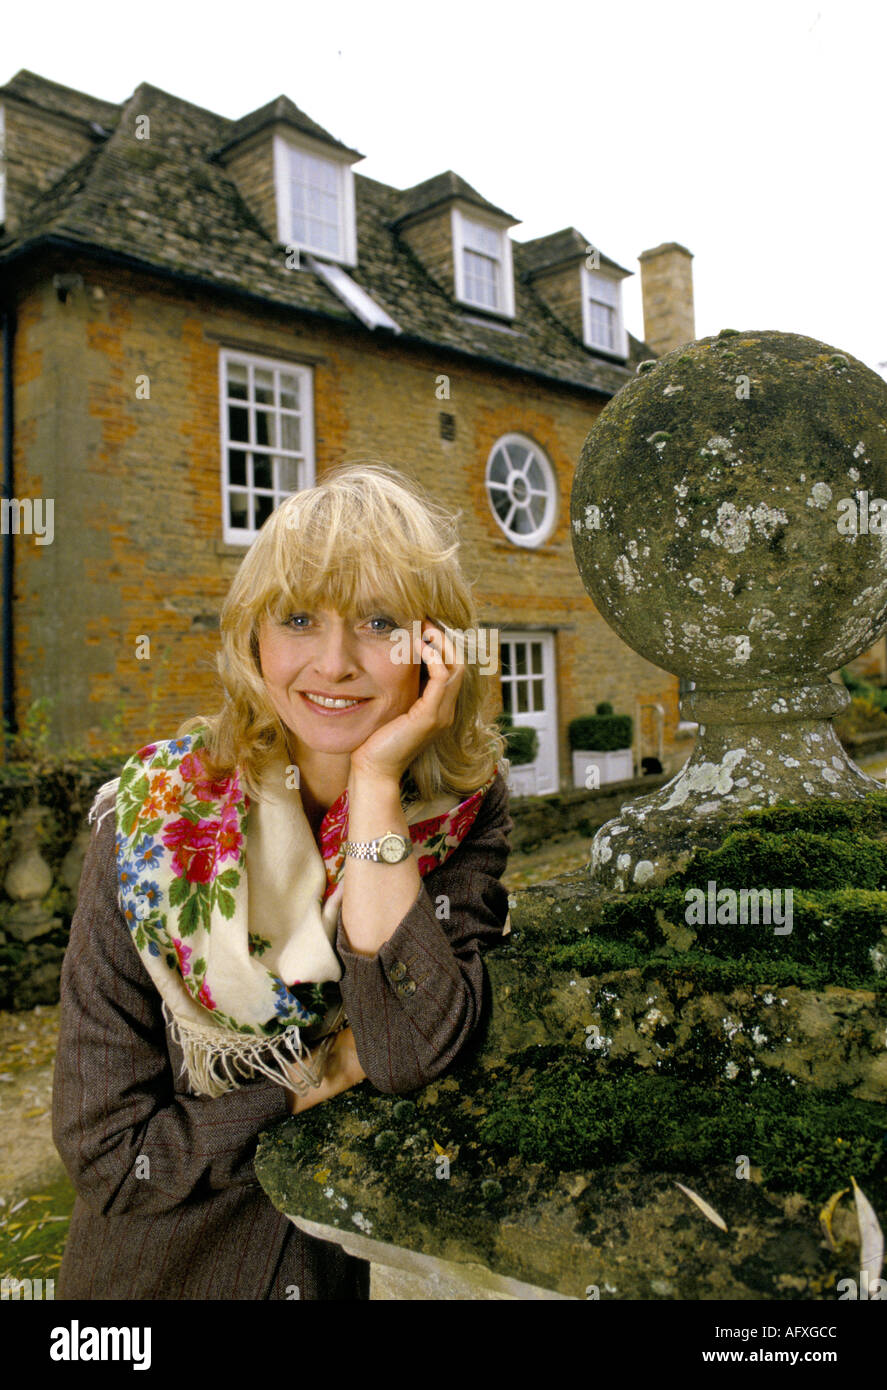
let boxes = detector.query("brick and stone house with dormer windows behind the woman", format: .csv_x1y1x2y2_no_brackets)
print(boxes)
0,71,694,792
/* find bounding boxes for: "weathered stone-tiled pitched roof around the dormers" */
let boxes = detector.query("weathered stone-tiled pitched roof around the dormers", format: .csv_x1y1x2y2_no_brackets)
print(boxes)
0,74,652,396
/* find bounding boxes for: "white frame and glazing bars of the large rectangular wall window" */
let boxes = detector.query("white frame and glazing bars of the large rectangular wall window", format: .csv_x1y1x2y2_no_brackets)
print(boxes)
218,348,316,545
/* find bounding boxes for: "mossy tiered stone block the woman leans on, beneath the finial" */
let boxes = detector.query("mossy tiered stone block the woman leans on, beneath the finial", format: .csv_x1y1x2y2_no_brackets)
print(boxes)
256,792,887,1300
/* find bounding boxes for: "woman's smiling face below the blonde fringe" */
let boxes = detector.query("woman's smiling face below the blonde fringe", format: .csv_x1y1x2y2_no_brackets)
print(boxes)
259,606,420,759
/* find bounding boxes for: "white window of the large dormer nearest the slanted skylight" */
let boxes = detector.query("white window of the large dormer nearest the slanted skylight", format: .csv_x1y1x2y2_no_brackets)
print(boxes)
274,135,357,265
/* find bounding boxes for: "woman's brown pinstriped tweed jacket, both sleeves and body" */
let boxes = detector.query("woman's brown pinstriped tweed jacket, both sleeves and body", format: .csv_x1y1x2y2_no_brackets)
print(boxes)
53,773,512,1300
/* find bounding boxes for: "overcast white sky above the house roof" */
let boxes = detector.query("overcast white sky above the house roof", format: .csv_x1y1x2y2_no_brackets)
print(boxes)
6,0,887,375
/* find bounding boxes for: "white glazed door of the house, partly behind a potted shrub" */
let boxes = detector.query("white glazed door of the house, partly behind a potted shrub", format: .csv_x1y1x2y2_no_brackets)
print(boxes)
499,630,560,795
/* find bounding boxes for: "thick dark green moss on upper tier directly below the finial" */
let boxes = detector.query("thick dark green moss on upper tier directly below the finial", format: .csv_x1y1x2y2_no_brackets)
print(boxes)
522,792,887,994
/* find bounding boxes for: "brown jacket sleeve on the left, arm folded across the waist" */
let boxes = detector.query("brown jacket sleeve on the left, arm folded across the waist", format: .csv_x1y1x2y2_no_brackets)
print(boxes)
53,813,289,1216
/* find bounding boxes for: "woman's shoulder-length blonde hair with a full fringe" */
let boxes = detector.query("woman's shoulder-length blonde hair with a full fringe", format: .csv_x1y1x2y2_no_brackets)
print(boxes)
177,464,507,801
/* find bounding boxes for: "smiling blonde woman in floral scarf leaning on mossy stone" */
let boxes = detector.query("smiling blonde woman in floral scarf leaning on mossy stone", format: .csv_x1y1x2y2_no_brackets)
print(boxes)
53,466,510,1298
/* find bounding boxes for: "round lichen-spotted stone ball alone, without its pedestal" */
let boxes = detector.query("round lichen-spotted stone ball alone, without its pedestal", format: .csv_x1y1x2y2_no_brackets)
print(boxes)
573,332,887,688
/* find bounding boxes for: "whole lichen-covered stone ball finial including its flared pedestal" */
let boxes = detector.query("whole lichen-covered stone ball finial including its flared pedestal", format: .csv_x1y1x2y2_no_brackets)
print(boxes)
571,331,887,888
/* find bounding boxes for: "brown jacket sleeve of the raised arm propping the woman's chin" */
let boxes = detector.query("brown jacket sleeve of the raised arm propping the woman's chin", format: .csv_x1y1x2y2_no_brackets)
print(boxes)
336,773,513,1093
